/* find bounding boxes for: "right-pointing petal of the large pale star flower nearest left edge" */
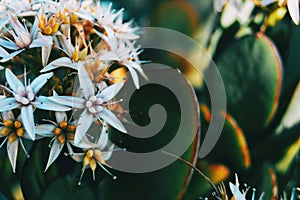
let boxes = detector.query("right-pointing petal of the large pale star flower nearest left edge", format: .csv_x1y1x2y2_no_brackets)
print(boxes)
32,96,71,111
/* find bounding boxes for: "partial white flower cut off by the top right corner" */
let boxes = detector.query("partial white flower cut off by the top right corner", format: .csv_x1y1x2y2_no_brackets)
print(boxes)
260,0,299,25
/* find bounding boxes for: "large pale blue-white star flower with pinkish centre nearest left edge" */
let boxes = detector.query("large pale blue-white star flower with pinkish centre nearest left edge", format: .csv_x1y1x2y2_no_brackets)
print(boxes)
0,69,70,140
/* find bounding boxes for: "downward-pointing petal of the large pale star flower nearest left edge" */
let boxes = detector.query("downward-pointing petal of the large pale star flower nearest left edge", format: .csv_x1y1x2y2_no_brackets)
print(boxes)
21,105,35,140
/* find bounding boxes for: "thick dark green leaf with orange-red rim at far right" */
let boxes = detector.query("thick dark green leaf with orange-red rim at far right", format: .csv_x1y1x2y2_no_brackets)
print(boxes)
216,34,282,135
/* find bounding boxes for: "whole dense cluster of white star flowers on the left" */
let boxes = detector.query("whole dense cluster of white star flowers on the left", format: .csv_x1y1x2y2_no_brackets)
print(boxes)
0,0,146,180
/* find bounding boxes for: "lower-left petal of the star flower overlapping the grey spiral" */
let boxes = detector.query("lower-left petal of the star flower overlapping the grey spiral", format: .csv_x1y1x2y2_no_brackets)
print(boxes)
74,110,93,145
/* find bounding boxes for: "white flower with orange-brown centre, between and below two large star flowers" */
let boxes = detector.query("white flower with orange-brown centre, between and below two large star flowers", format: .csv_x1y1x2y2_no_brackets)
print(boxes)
35,112,76,171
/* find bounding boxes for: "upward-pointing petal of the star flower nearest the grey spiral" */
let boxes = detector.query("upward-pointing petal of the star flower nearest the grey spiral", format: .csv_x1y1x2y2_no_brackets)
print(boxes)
78,65,95,99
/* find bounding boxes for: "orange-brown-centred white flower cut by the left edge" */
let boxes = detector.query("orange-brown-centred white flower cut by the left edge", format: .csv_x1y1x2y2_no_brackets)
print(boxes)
0,111,29,173
